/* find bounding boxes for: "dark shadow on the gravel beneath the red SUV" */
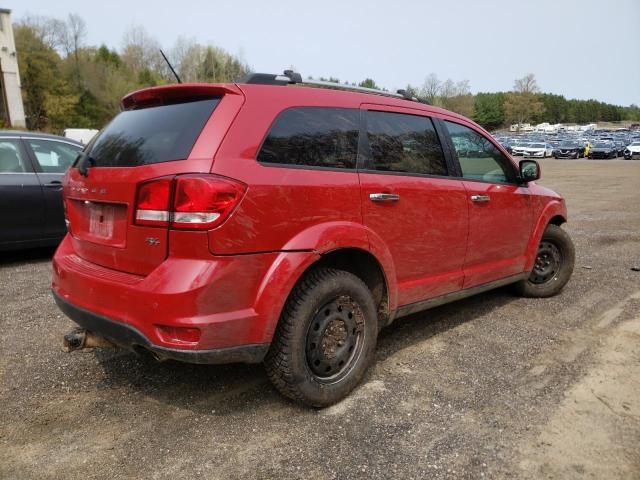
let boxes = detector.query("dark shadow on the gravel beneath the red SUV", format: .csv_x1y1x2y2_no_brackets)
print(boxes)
95,288,516,415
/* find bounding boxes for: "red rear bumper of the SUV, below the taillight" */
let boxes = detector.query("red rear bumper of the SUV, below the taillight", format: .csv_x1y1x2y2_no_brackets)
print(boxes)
52,236,314,363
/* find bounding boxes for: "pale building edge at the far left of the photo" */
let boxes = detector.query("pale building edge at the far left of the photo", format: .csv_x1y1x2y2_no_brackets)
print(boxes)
0,8,26,128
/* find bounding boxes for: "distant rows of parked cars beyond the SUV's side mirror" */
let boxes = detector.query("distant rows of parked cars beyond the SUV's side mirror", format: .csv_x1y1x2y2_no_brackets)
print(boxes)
495,130,640,160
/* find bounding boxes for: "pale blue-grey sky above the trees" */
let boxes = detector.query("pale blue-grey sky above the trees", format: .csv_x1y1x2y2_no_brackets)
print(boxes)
10,0,640,105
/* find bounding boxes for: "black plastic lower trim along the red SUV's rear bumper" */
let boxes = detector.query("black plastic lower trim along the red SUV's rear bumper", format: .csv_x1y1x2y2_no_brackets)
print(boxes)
53,292,269,364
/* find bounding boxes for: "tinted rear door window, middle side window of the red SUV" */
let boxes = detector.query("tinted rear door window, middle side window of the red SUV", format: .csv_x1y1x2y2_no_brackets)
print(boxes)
366,111,447,176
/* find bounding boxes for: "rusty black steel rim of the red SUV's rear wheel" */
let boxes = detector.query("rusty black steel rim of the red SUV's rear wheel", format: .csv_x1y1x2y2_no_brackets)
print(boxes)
305,295,365,383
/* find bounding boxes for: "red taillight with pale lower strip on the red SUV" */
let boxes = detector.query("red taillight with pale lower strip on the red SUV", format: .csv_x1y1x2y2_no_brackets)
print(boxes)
135,175,246,230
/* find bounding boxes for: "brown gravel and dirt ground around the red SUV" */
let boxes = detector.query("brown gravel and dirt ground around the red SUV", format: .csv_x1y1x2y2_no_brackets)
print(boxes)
0,160,640,479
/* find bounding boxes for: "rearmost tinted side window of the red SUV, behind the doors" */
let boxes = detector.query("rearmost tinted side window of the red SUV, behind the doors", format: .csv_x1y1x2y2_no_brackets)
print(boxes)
258,107,360,169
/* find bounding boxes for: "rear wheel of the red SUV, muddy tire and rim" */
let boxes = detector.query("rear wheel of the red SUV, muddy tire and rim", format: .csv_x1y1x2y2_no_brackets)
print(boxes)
264,268,378,407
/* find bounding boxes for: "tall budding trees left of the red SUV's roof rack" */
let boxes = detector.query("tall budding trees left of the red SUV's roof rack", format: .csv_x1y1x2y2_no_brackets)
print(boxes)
14,14,249,133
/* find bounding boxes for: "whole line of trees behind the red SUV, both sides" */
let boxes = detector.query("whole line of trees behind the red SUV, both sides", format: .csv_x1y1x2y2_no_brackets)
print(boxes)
14,14,640,133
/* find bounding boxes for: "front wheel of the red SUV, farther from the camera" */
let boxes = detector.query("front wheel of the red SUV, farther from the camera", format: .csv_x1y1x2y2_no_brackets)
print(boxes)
514,225,575,297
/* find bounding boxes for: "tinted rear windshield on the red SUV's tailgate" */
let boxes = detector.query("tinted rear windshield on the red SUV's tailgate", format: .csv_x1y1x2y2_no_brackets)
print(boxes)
88,98,220,167
